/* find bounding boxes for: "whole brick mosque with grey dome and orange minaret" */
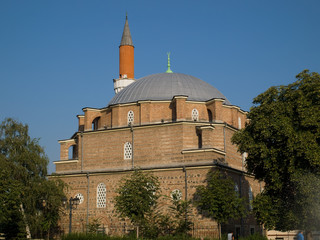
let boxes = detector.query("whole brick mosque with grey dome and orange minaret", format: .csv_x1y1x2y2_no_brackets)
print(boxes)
51,17,261,237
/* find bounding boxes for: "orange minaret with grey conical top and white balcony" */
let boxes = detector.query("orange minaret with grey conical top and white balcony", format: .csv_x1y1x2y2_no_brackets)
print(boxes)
113,15,135,93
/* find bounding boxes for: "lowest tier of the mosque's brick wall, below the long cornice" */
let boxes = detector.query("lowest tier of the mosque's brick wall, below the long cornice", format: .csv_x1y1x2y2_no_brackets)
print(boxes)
54,166,260,235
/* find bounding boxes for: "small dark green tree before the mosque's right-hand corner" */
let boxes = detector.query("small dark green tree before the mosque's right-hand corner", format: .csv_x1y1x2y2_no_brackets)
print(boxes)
194,171,245,238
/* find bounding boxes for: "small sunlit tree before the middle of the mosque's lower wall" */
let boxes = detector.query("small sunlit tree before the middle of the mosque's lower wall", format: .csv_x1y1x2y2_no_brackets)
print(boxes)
115,170,160,239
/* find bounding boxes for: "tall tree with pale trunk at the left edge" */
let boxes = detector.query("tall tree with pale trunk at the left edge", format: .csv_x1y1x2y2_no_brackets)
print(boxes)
0,118,64,239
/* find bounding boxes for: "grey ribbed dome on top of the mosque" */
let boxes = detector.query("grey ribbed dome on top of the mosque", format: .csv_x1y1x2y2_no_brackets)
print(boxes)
108,73,231,106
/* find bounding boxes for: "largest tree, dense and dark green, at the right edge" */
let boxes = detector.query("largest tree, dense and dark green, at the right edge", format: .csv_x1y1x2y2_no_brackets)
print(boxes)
232,70,320,230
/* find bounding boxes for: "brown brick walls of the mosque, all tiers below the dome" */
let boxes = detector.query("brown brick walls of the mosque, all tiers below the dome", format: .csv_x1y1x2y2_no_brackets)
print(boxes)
56,96,261,235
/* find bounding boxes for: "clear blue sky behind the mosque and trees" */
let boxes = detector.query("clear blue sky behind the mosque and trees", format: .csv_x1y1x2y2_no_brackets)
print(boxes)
0,0,320,172
